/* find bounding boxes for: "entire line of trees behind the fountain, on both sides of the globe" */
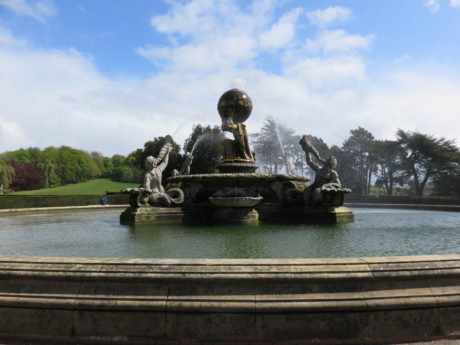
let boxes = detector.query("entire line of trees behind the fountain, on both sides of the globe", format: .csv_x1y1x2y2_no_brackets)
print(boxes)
0,117,460,197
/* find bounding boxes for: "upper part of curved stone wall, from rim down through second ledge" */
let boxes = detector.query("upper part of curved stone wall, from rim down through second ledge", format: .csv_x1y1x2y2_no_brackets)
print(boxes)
0,254,460,312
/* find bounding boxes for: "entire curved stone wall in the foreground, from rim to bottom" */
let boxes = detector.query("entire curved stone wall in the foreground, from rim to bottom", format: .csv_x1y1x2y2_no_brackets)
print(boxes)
0,255,460,344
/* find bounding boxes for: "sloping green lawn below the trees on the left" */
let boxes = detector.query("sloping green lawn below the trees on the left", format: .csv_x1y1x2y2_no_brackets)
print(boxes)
11,178,139,195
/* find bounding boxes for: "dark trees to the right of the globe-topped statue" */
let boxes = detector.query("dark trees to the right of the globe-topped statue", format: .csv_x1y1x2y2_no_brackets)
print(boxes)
253,117,460,197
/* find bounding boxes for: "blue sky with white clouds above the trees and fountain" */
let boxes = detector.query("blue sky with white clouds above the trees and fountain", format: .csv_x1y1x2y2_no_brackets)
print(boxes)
0,0,460,156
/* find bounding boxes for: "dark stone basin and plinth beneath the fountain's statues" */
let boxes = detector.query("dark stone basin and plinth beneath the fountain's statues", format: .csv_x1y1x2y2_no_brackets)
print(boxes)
120,173,354,224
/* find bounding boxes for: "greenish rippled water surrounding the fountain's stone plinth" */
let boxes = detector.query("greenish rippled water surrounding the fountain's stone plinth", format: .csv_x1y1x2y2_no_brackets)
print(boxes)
0,209,460,258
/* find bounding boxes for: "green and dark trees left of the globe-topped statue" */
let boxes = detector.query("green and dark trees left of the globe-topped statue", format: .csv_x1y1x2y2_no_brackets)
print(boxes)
0,125,223,192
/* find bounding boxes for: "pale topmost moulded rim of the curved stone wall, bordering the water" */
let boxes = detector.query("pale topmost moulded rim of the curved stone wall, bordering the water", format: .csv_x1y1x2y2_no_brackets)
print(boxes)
0,254,460,284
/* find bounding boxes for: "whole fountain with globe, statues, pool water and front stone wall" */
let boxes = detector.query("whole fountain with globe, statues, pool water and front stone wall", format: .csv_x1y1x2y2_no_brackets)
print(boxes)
0,90,460,345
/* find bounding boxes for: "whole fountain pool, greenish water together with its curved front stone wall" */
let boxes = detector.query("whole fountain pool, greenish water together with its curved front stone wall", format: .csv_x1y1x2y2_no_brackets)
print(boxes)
0,208,460,345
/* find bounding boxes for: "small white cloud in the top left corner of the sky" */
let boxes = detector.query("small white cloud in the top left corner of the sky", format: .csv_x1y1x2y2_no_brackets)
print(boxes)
0,0,57,22
